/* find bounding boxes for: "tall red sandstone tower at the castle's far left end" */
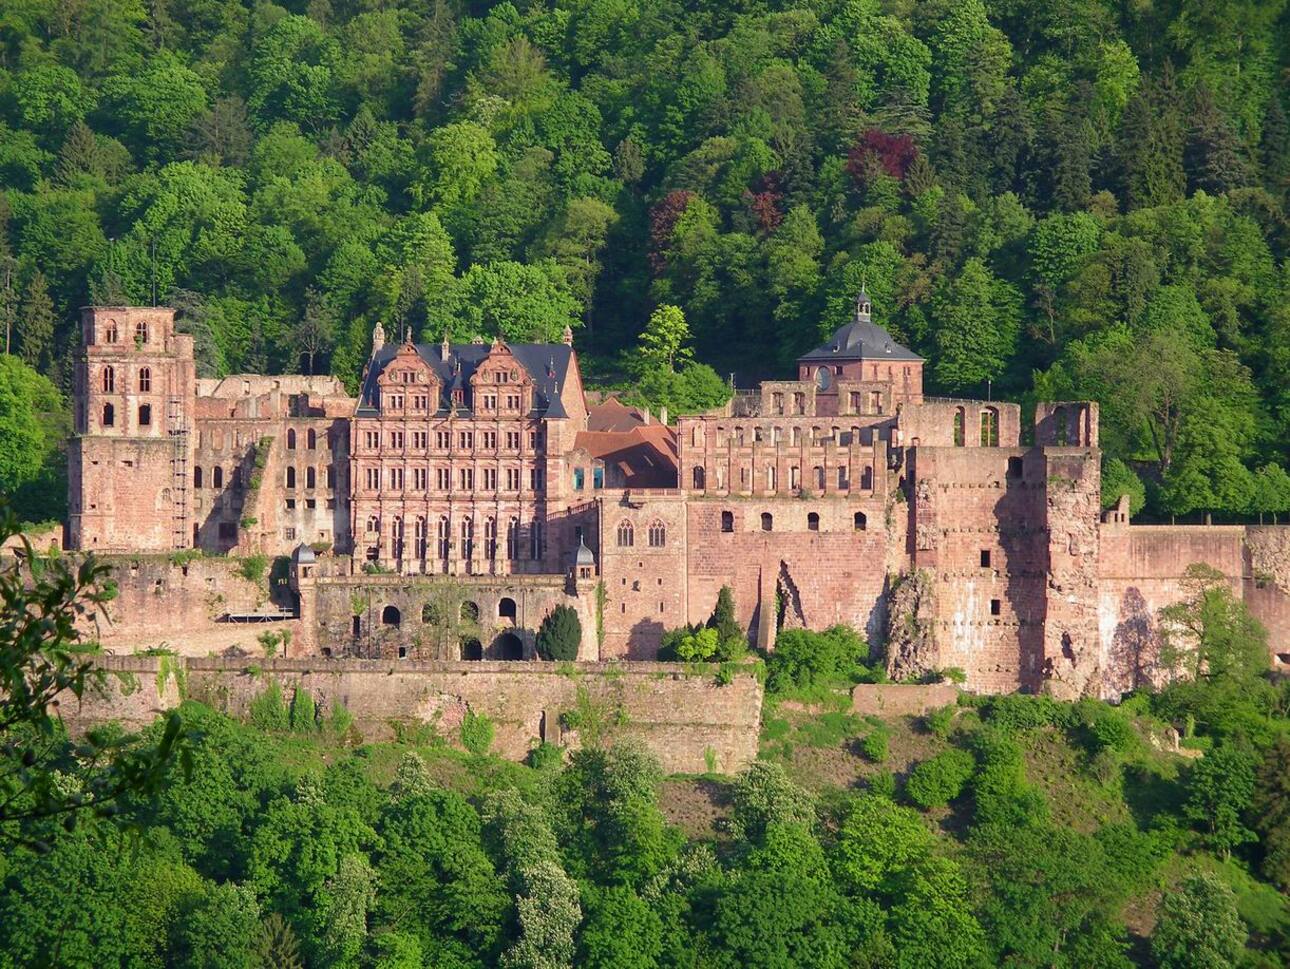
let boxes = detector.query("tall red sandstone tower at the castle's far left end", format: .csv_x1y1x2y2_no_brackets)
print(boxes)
67,306,196,551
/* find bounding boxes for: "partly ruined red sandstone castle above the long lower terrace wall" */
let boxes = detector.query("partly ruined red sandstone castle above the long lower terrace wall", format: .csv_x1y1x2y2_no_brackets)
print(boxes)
67,293,1290,697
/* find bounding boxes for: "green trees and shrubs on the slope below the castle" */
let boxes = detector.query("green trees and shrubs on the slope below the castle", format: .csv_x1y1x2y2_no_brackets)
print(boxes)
0,563,1290,969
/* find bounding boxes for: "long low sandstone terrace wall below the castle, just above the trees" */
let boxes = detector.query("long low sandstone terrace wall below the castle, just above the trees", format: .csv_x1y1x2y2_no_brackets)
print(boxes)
62,657,762,773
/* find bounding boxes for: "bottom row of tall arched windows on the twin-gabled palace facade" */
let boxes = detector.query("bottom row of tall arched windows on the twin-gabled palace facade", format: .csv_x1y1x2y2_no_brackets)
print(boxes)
364,515,546,561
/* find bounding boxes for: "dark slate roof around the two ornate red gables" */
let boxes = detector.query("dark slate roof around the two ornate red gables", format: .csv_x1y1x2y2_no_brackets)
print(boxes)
357,343,573,418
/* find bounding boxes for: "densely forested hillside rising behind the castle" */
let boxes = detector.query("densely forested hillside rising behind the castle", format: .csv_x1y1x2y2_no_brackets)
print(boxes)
0,0,1290,515
